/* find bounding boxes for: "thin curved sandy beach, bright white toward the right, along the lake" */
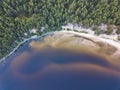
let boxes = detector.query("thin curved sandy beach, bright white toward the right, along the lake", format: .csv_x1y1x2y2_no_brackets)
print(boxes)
0,30,120,62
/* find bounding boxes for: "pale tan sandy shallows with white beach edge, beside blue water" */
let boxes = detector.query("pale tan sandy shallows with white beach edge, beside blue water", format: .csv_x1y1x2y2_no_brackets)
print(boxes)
30,31,120,61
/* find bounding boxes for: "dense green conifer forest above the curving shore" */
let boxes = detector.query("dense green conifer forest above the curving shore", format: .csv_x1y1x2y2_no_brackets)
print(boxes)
0,0,120,58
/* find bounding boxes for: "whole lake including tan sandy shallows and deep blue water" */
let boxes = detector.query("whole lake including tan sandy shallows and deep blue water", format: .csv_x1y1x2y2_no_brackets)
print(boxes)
0,31,120,90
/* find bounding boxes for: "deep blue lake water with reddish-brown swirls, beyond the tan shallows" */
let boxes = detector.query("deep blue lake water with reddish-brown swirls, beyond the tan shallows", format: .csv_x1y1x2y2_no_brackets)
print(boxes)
0,38,120,90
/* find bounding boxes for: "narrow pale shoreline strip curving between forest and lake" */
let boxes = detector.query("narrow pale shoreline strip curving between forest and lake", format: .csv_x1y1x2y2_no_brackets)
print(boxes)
0,30,120,63
